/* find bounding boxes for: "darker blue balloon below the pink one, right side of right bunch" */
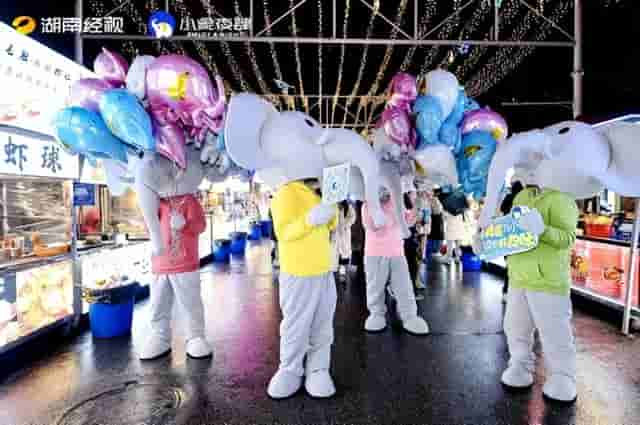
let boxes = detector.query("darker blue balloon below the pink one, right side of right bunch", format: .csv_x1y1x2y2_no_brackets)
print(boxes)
457,130,498,199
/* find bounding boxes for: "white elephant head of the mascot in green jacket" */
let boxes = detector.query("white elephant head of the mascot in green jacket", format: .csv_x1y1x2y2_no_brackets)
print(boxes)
479,121,640,228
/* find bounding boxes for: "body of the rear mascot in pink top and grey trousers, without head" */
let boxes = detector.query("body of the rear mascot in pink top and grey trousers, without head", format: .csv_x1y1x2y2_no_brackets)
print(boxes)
362,189,429,335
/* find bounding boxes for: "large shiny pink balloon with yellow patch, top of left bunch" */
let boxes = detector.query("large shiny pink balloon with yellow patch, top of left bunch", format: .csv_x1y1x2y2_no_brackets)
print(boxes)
147,55,225,138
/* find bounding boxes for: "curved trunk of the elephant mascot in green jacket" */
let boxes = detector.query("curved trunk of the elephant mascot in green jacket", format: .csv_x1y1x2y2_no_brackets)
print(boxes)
478,130,552,229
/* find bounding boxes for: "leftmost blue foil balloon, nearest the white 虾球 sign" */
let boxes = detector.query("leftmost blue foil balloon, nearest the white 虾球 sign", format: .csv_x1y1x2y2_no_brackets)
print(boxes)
53,106,127,163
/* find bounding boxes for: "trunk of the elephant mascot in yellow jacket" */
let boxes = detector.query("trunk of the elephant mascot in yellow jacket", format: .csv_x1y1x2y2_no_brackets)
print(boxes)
322,129,385,227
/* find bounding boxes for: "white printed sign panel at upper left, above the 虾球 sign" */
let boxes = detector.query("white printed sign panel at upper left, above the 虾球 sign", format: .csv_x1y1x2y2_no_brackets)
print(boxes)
0,23,96,135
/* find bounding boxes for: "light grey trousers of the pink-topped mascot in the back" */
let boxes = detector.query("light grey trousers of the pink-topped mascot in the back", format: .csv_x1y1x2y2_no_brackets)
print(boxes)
364,256,418,322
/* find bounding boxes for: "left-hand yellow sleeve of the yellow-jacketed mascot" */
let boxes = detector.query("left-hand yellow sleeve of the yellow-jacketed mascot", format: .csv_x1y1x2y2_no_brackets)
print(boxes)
271,186,313,241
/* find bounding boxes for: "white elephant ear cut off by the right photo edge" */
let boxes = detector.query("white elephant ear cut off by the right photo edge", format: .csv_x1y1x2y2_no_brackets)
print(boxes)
597,122,640,197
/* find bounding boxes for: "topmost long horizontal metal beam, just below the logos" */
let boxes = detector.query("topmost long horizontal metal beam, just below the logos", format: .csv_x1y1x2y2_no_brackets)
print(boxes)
82,34,575,48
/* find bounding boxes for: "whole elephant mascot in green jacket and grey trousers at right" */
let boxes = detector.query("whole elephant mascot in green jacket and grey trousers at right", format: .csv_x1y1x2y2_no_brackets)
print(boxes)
479,122,640,402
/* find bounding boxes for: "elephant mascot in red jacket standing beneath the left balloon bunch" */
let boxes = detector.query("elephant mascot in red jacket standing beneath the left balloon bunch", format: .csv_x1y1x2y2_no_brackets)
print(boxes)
105,143,232,360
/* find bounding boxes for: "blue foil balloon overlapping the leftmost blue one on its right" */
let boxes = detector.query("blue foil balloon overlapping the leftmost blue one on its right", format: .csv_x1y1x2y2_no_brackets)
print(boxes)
100,89,156,152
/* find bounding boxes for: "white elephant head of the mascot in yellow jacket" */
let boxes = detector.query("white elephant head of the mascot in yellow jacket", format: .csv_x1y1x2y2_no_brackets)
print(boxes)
225,93,384,226
